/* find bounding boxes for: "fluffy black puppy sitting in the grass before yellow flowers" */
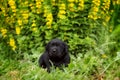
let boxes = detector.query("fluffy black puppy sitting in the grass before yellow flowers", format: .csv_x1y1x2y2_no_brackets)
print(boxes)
39,39,70,72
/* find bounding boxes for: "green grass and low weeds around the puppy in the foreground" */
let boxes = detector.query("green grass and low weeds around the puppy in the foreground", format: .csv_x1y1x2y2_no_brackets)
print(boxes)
0,51,120,80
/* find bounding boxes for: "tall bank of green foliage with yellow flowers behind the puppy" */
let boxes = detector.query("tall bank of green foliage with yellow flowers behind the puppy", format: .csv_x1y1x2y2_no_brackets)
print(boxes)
0,0,119,55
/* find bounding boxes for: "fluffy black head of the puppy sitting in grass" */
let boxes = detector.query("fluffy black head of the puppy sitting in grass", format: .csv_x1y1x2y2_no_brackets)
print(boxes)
46,39,68,58
